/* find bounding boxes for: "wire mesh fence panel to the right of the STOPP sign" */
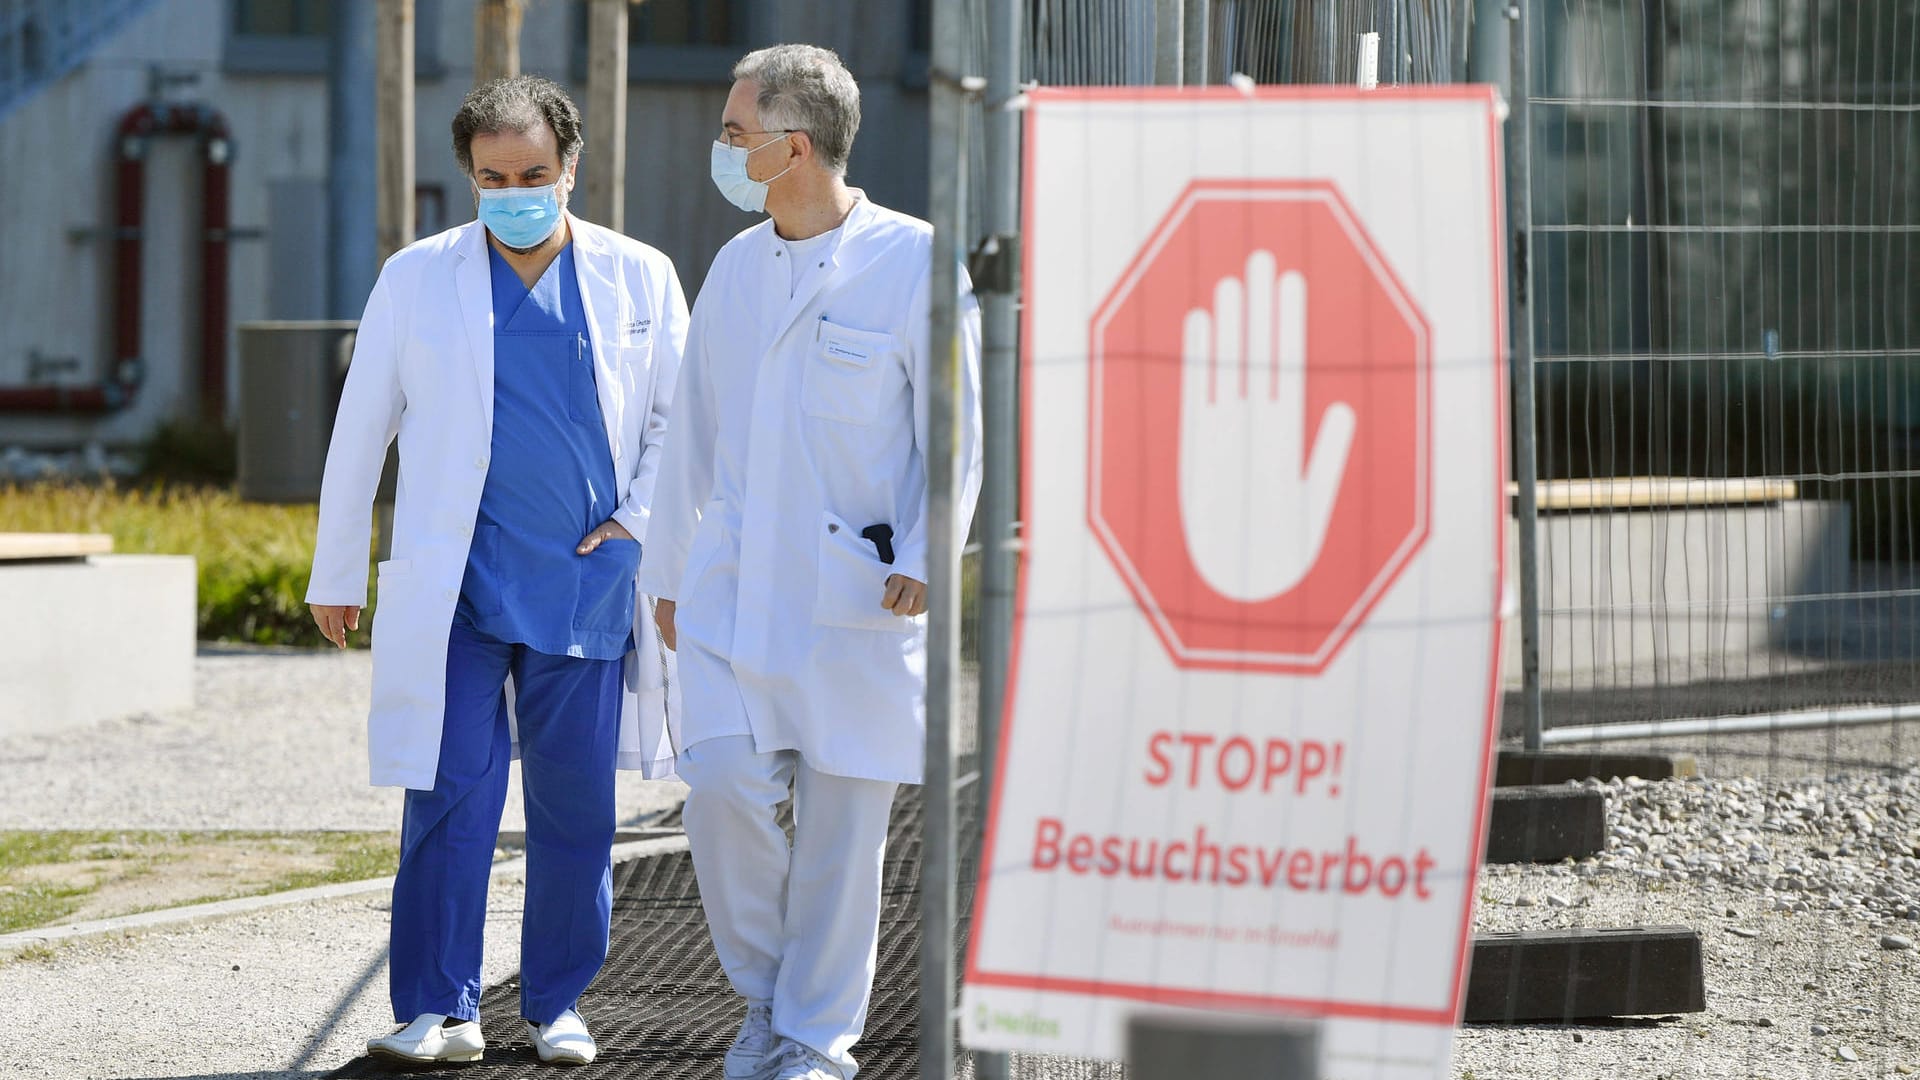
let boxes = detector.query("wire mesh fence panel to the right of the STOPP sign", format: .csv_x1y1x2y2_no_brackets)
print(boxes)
1505,0,1920,749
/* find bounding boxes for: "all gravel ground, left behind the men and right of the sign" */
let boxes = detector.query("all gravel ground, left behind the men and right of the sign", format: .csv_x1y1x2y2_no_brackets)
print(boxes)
0,653,1920,1080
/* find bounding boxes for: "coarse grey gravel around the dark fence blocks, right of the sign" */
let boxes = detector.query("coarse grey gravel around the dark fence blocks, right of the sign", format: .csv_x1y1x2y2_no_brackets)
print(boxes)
1453,728,1920,1080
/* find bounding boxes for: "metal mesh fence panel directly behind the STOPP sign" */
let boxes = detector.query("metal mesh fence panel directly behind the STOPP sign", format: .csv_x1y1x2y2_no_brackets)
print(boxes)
922,0,1475,1080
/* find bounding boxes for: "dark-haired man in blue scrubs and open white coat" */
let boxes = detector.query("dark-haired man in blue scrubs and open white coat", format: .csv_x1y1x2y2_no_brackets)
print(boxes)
303,77,685,1065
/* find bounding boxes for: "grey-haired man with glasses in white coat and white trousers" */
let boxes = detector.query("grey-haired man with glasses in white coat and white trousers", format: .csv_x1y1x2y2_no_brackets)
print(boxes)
639,44,981,1080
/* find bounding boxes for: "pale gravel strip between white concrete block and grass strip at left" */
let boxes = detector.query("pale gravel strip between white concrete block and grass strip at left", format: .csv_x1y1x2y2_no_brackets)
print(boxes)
0,646,685,830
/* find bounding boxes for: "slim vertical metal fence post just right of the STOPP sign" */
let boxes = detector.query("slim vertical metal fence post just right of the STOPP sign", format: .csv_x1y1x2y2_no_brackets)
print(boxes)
1507,0,1542,749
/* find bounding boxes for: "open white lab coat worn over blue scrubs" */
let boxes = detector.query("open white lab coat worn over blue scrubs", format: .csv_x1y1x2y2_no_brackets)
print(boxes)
307,217,687,790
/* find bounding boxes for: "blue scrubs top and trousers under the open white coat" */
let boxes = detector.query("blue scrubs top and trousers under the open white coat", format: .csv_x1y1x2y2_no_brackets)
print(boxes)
372,189,639,1061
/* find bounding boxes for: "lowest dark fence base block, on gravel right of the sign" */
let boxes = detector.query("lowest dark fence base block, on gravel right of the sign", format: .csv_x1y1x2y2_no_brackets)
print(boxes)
1461,926,1707,1024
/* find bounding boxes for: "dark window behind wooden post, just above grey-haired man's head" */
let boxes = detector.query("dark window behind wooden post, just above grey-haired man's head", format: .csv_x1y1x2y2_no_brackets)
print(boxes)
574,0,756,83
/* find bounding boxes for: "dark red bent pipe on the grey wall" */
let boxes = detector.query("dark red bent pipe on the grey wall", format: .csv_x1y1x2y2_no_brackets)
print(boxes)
0,104,232,413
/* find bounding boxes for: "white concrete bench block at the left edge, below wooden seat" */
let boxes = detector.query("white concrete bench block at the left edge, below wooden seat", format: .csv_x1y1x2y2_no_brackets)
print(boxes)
0,555,198,736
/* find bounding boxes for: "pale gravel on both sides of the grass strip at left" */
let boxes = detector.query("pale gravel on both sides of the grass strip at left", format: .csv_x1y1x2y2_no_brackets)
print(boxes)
0,646,685,1080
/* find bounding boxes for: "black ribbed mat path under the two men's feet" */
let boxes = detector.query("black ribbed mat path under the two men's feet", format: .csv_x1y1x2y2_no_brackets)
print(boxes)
328,788,972,1080
